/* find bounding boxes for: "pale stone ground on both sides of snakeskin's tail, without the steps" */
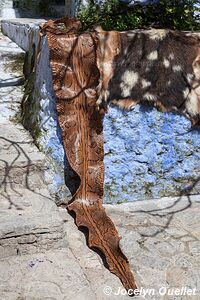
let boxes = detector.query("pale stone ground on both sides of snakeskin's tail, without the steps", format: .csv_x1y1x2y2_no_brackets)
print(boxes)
0,196,200,300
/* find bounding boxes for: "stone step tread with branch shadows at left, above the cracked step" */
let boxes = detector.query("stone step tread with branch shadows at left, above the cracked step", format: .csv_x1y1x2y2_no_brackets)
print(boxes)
0,122,47,191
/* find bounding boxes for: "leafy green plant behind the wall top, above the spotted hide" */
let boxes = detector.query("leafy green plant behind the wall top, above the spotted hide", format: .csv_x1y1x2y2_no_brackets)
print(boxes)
77,0,200,31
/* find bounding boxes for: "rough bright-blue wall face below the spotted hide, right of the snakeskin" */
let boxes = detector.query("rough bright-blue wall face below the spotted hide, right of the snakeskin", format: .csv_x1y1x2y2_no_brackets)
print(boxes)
104,105,200,203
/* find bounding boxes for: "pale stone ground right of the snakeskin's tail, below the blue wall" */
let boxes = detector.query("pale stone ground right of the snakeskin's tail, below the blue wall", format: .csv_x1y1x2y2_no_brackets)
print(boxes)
105,195,200,300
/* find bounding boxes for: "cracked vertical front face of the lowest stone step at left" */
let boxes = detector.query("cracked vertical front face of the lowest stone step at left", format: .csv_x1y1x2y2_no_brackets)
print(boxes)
0,212,67,258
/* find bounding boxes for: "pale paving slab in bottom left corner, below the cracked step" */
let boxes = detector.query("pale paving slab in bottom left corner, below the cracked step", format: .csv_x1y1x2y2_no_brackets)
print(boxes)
0,249,95,300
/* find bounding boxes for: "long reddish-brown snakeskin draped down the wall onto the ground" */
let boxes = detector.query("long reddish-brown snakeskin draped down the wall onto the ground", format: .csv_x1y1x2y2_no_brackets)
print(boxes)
41,19,136,290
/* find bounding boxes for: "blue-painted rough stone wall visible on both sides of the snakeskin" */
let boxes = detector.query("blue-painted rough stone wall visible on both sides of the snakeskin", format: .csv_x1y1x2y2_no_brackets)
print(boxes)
2,22,200,203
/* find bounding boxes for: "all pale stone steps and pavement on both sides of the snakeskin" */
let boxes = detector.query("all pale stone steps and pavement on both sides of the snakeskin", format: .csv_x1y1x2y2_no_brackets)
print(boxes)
0,24,200,300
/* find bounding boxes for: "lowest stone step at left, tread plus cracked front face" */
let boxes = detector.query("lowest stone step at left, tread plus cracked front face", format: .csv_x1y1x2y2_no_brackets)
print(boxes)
0,186,66,258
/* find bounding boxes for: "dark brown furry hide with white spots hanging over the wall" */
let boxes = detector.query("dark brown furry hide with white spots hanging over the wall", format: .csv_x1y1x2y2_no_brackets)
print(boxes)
96,27,200,125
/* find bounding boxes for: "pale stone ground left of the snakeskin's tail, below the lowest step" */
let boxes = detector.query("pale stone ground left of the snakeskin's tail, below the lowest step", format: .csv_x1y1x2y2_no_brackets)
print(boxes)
0,208,128,300
